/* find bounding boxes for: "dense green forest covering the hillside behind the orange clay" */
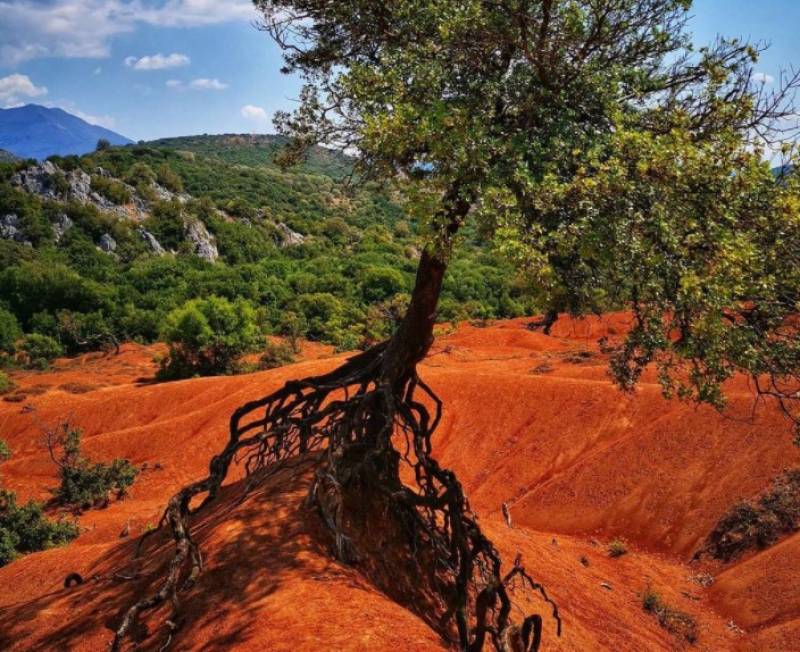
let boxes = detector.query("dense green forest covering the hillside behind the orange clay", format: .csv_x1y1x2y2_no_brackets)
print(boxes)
0,136,533,372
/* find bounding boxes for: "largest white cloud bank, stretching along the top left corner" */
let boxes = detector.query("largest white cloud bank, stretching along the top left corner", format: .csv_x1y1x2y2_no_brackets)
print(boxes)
0,0,256,66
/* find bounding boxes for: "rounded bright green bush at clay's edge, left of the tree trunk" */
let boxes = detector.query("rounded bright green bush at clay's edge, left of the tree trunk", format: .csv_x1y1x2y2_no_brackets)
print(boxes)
159,296,261,380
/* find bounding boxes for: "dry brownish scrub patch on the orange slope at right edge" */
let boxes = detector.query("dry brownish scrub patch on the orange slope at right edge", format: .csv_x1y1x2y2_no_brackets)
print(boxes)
695,469,800,562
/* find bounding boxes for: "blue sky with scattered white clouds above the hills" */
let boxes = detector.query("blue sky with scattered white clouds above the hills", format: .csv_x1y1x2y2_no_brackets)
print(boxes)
0,0,800,140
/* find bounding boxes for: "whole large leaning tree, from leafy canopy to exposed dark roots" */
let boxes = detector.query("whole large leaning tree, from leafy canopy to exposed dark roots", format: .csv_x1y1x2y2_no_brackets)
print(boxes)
115,0,800,651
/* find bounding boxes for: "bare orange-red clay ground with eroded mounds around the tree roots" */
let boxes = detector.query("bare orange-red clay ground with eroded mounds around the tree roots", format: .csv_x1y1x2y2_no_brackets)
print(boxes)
0,315,800,652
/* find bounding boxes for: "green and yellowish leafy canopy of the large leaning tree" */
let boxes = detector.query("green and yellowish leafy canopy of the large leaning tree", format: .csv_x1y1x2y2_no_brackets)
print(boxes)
256,0,800,432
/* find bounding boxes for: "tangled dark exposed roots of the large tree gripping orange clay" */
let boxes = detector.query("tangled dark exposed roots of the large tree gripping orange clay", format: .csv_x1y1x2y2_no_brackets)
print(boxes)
112,343,561,652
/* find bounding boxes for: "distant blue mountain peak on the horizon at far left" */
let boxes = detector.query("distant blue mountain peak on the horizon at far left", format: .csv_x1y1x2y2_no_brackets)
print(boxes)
0,104,132,160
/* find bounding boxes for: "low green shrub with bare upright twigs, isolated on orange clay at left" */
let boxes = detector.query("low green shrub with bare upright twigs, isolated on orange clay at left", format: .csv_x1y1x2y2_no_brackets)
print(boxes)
47,422,139,509
